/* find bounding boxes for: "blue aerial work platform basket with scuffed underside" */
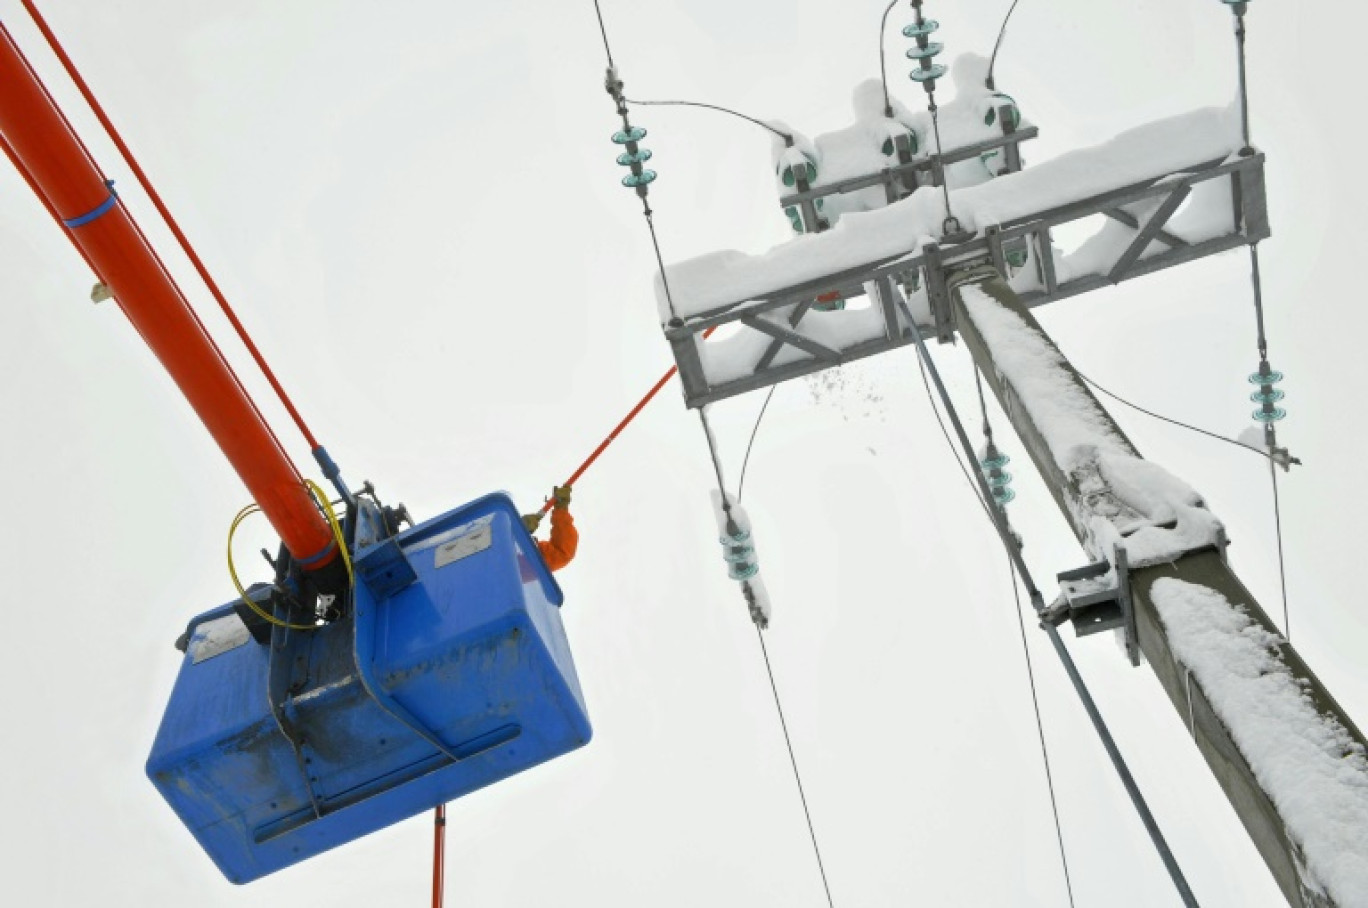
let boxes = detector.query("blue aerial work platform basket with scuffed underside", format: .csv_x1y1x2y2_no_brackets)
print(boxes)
148,494,591,883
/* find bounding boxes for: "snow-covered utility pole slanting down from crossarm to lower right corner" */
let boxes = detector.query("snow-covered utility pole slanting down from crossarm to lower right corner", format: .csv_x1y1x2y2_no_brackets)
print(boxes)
952,268,1368,908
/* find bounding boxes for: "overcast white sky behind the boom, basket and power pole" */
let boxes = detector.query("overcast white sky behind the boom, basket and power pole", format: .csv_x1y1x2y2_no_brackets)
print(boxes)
0,0,1368,908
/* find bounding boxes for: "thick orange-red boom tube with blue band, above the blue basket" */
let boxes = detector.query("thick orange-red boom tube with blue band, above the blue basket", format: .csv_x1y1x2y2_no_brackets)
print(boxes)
0,25,339,574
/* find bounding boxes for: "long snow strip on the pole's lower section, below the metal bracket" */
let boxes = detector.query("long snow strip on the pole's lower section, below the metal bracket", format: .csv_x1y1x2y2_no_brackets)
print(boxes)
1152,578,1368,908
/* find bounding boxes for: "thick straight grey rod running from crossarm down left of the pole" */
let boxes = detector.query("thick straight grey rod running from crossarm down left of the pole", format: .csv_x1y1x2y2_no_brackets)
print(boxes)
896,294,1197,908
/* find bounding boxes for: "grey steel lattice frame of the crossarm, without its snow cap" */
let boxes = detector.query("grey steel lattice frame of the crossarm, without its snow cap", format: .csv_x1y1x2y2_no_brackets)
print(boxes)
666,153,1270,408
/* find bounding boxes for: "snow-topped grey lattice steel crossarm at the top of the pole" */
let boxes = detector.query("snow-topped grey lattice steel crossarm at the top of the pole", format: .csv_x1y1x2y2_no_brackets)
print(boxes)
657,102,1270,408
